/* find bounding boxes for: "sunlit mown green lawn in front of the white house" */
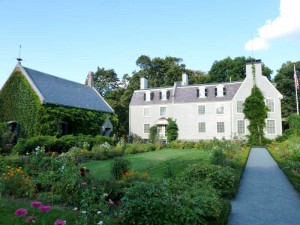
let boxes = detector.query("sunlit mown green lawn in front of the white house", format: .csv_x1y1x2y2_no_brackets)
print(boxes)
83,149,210,178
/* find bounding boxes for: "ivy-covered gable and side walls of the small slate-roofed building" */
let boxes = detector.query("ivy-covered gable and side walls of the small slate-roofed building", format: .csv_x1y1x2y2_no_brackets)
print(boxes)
0,72,117,138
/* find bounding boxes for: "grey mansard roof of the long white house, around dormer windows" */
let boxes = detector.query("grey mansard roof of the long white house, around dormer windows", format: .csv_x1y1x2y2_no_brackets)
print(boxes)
130,82,242,106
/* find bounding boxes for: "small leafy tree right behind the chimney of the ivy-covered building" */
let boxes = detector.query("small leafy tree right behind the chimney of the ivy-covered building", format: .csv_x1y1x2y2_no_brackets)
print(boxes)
94,67,119,97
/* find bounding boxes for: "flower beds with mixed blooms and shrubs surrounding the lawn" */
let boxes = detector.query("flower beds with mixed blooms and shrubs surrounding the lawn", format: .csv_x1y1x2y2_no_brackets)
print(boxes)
0,137,247,225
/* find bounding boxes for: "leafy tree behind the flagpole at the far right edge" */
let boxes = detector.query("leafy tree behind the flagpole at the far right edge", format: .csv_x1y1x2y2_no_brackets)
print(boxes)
274,61,300,118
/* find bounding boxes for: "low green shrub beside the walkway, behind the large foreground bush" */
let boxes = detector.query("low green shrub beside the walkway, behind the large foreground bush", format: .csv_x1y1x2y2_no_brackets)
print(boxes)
183,164,236,198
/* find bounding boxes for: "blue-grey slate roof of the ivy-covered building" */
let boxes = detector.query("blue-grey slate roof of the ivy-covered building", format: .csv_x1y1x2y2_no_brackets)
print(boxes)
17,64,114,113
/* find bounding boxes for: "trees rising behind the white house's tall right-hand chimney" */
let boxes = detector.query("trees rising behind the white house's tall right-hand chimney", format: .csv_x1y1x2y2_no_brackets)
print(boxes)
208,56,272,82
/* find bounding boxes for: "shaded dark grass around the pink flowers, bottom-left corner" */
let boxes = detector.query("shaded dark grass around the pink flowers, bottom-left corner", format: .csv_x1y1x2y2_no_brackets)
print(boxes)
0,198,77,225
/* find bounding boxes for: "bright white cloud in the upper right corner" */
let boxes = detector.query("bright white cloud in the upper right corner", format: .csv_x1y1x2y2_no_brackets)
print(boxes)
245,0,300,51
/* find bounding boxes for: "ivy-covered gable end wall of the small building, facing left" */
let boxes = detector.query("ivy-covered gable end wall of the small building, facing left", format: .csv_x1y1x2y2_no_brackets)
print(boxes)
0,71,40,137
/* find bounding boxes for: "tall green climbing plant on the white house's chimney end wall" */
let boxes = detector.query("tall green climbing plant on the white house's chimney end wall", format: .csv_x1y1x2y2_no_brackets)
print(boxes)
243,85,269,145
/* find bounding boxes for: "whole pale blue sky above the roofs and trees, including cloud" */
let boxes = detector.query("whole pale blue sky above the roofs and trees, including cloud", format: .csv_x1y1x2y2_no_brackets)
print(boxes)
0,0,300,87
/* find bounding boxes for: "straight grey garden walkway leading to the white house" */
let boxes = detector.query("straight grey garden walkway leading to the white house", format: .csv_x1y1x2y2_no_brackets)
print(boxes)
228,148,300,225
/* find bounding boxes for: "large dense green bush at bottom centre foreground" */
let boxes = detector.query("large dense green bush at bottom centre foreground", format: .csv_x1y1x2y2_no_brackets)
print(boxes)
120,180,230,225
